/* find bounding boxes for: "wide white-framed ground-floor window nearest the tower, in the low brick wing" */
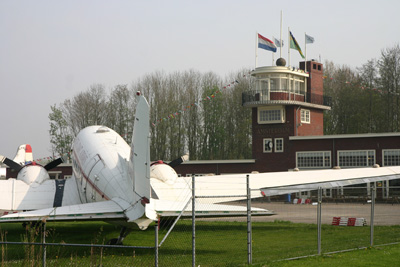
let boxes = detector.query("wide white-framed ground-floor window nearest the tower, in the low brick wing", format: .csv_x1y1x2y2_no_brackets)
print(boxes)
296,151,331,168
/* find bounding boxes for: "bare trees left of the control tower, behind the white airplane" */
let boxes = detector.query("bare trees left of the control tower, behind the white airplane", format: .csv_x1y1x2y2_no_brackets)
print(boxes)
49,70,254,160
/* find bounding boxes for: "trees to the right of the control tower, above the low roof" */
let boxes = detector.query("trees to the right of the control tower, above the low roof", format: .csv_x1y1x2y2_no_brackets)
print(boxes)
324,45,400,134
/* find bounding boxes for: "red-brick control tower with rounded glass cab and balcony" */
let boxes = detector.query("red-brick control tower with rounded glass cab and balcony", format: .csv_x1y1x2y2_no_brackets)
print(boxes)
242,58,330,171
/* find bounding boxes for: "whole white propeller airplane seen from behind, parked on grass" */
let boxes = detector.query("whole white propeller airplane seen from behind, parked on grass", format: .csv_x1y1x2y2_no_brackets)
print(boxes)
0,92,400,244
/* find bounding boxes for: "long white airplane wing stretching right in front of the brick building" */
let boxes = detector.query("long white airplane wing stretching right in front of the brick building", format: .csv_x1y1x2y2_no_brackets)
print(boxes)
151,166,400,203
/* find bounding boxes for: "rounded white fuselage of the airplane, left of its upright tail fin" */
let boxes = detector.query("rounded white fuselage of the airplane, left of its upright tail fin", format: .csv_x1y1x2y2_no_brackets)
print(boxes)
72,126,133,206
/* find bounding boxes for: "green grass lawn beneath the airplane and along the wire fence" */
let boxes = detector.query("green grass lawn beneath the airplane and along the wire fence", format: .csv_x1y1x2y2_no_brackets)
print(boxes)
0,220,400,266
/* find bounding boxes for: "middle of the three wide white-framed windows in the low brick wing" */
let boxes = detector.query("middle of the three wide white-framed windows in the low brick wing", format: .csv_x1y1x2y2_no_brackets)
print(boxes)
338,150,375,167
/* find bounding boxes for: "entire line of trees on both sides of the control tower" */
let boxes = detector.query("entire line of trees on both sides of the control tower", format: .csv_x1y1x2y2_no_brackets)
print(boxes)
49,45,400,160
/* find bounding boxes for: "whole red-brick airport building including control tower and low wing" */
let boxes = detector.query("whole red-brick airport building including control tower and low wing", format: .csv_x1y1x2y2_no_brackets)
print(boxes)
177,59,400,178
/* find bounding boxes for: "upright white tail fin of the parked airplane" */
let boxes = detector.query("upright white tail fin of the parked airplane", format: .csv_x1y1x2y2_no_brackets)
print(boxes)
129,92,150,212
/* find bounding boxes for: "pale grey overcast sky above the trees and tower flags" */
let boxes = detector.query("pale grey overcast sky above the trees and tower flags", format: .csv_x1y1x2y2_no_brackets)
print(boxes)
0,0,400,159
